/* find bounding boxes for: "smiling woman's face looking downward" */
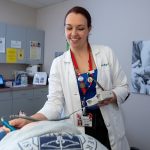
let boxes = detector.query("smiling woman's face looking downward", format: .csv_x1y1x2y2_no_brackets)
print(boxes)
65,13,91,48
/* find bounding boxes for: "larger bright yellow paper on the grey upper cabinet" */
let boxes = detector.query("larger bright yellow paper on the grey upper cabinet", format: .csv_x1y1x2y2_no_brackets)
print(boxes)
6,48,17,63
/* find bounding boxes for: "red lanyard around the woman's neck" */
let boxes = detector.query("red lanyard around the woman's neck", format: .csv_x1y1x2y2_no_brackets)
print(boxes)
70,45,93,75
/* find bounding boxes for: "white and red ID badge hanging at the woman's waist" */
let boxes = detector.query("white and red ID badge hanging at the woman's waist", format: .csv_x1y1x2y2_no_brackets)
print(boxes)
77,113,93,127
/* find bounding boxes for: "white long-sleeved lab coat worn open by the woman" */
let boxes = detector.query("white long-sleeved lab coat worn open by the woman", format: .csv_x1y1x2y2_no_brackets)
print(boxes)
39,46,129,150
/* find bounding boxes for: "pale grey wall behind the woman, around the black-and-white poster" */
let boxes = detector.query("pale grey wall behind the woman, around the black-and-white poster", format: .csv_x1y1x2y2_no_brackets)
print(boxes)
37,0,150,150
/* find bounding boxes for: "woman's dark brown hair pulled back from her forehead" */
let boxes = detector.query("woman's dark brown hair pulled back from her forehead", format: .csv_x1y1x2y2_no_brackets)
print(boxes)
64,6,91,28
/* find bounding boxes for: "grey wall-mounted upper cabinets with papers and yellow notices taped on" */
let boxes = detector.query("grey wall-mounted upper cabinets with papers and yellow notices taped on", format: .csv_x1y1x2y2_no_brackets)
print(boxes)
0,23,45,64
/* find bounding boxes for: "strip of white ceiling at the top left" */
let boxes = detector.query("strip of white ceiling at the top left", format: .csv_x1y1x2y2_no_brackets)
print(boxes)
9,0,66,8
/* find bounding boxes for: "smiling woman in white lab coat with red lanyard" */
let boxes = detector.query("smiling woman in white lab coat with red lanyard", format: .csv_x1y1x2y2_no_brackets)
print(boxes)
4,6,129,150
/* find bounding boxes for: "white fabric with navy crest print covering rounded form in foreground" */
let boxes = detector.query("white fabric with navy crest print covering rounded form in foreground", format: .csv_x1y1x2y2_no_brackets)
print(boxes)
0,120,107,150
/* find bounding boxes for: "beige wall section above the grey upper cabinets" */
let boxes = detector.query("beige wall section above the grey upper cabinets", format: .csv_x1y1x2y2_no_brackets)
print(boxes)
0,0,36,27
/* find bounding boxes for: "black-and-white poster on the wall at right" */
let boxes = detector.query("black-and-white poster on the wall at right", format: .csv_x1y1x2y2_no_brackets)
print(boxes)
131,40,150,95
